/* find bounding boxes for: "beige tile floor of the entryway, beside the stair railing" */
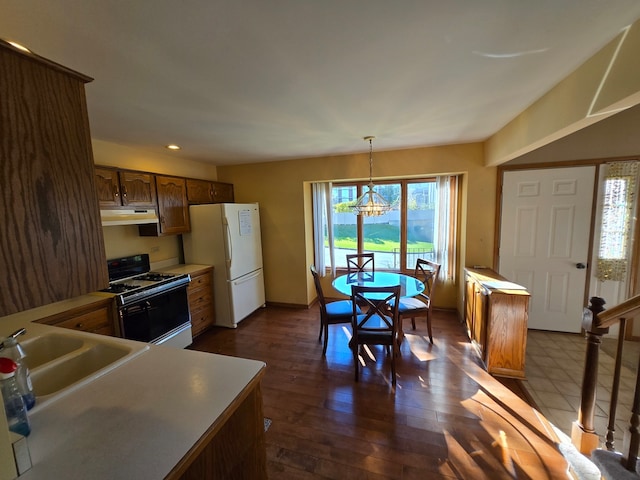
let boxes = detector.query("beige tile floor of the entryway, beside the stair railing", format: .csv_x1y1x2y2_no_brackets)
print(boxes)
523,330,637,450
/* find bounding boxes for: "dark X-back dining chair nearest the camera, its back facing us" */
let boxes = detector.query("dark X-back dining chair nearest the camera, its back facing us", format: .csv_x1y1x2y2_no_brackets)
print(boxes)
349,285,400,387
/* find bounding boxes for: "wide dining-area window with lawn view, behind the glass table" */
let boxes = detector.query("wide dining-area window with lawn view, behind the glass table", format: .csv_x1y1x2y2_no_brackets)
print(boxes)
314,176,458,279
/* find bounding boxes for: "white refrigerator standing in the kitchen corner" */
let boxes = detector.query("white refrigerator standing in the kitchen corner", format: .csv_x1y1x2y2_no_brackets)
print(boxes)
182,203,265,328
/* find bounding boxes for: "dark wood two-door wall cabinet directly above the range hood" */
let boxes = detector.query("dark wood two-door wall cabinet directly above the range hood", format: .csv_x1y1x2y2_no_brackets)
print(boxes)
95,167,156,208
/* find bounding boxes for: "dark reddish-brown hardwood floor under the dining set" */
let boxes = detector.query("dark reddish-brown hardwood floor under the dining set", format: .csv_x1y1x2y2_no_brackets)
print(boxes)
191,307,567,480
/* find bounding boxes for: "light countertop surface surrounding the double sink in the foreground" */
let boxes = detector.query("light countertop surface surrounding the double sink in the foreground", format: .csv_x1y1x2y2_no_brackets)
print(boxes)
0,286,265,480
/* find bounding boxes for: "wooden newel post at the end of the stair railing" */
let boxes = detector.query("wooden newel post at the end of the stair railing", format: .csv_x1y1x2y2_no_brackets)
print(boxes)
571,297,609,455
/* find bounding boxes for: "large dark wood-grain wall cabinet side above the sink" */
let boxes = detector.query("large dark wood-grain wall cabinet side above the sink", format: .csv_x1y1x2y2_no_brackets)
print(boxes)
0,41,109,317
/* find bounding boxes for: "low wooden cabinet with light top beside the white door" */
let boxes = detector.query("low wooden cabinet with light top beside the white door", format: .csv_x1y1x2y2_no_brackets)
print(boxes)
465,268,529,378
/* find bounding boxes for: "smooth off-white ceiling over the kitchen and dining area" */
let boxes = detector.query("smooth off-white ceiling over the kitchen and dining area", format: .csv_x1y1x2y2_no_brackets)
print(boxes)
0,0,640,165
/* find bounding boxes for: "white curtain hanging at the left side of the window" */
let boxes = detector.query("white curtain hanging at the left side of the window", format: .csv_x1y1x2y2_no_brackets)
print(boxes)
311,182,336,277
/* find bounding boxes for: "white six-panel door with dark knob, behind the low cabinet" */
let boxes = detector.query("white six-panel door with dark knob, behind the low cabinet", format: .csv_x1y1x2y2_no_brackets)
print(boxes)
499,166,595,332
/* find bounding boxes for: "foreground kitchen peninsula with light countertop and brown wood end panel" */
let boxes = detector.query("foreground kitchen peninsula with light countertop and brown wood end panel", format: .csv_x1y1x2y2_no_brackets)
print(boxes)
0,295,266,480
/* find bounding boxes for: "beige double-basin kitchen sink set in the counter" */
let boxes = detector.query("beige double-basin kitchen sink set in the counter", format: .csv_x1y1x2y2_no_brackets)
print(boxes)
20,332,149,408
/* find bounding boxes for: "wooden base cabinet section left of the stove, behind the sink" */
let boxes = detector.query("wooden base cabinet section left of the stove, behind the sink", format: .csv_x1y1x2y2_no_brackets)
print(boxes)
36,298,116,337
